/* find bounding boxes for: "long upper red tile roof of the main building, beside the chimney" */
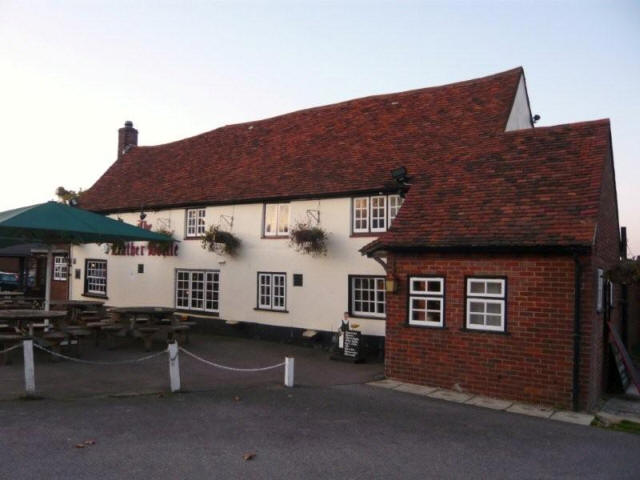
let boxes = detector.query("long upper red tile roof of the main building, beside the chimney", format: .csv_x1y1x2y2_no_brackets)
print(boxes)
81,68,523,212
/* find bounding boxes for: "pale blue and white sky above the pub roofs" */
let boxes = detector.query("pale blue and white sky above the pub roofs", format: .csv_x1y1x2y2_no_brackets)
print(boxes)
0,0,640,255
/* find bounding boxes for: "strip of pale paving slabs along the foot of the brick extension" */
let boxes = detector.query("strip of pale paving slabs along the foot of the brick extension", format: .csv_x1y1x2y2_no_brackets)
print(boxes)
367,378,595,426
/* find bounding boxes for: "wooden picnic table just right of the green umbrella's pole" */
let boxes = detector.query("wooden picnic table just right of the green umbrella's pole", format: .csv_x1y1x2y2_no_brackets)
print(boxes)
103,306,191,351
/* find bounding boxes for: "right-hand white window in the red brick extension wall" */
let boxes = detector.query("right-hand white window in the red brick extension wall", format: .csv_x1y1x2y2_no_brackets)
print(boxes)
466,278,507,332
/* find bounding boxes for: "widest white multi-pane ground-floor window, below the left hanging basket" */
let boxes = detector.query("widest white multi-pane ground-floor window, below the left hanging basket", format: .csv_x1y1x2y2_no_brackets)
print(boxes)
176,270,220,313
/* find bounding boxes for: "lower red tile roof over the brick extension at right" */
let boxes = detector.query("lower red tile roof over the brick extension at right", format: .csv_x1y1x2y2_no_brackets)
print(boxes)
362,120,611,253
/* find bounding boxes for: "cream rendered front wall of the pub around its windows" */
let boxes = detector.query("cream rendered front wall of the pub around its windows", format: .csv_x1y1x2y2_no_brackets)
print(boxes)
71,198,385,336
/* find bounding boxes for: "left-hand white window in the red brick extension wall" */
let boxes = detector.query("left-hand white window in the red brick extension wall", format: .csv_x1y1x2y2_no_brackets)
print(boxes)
409,277,444,327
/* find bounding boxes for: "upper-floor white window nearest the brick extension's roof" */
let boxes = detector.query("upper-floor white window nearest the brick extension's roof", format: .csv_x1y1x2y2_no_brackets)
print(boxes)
352,195,403,233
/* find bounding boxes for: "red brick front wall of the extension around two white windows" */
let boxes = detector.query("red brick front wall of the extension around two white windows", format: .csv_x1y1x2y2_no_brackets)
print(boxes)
385,253,590,408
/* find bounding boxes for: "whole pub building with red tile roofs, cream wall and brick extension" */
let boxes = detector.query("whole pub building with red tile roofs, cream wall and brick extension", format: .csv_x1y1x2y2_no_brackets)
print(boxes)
69,68,621,409
